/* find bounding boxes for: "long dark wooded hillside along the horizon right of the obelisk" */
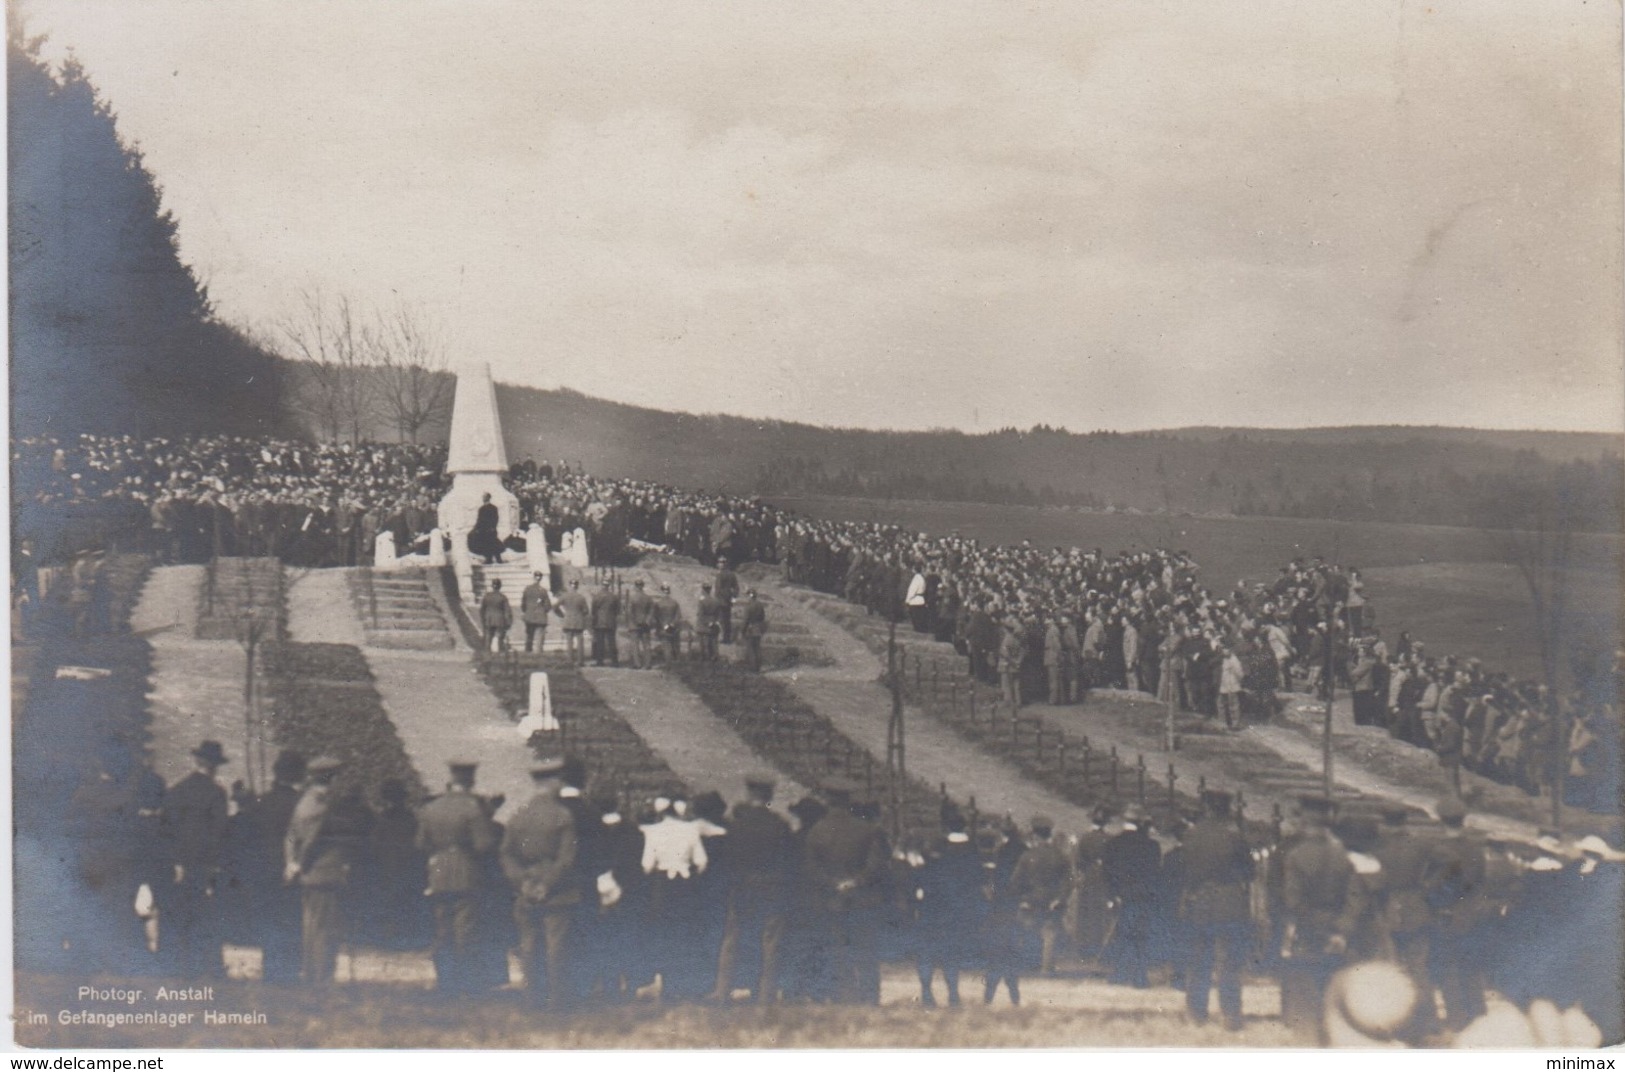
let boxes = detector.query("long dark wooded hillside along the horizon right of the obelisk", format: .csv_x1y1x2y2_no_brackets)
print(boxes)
269,364,1625,531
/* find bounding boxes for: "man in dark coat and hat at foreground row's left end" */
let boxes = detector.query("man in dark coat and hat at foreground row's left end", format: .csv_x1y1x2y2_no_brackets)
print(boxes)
159,741,229,978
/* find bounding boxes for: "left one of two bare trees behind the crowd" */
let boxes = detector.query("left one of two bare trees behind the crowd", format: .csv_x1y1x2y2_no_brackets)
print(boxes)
278,289,375,442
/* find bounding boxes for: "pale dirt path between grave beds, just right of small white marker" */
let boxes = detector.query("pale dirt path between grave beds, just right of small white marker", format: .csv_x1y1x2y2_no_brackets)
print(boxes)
582,666,806,815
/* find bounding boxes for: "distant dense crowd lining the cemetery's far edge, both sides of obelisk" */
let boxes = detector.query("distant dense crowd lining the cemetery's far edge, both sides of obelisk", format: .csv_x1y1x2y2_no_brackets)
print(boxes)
11,435,1625,810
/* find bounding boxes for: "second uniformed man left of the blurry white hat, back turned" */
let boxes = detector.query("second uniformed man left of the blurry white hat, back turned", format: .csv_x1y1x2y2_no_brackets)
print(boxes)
1180,789,1253,1031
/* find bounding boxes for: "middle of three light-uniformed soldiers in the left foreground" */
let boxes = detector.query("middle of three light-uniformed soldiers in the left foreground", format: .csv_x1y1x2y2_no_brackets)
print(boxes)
418,760,496,996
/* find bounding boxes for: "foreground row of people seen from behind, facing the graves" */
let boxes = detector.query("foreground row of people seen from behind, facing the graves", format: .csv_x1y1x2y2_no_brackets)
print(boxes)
57,741,1625,1044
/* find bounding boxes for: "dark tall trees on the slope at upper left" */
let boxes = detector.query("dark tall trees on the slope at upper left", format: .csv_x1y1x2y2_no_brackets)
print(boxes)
7,22,288,435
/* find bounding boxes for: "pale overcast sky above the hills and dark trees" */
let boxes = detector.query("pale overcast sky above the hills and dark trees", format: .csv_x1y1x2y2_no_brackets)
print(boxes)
23,0,1625,430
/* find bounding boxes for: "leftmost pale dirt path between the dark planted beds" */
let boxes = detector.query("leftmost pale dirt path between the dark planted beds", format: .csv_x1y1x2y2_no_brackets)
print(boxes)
130,565,247,785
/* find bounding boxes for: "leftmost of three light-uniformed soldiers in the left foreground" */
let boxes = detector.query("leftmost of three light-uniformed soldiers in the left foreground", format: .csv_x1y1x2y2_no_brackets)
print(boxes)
283,755,371,986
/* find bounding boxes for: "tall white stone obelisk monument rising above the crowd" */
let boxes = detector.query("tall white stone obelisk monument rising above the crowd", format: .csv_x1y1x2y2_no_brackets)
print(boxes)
439,361,518,554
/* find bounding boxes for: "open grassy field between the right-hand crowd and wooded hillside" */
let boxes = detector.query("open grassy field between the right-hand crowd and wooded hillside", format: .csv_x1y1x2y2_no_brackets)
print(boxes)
774,495,1622,676
